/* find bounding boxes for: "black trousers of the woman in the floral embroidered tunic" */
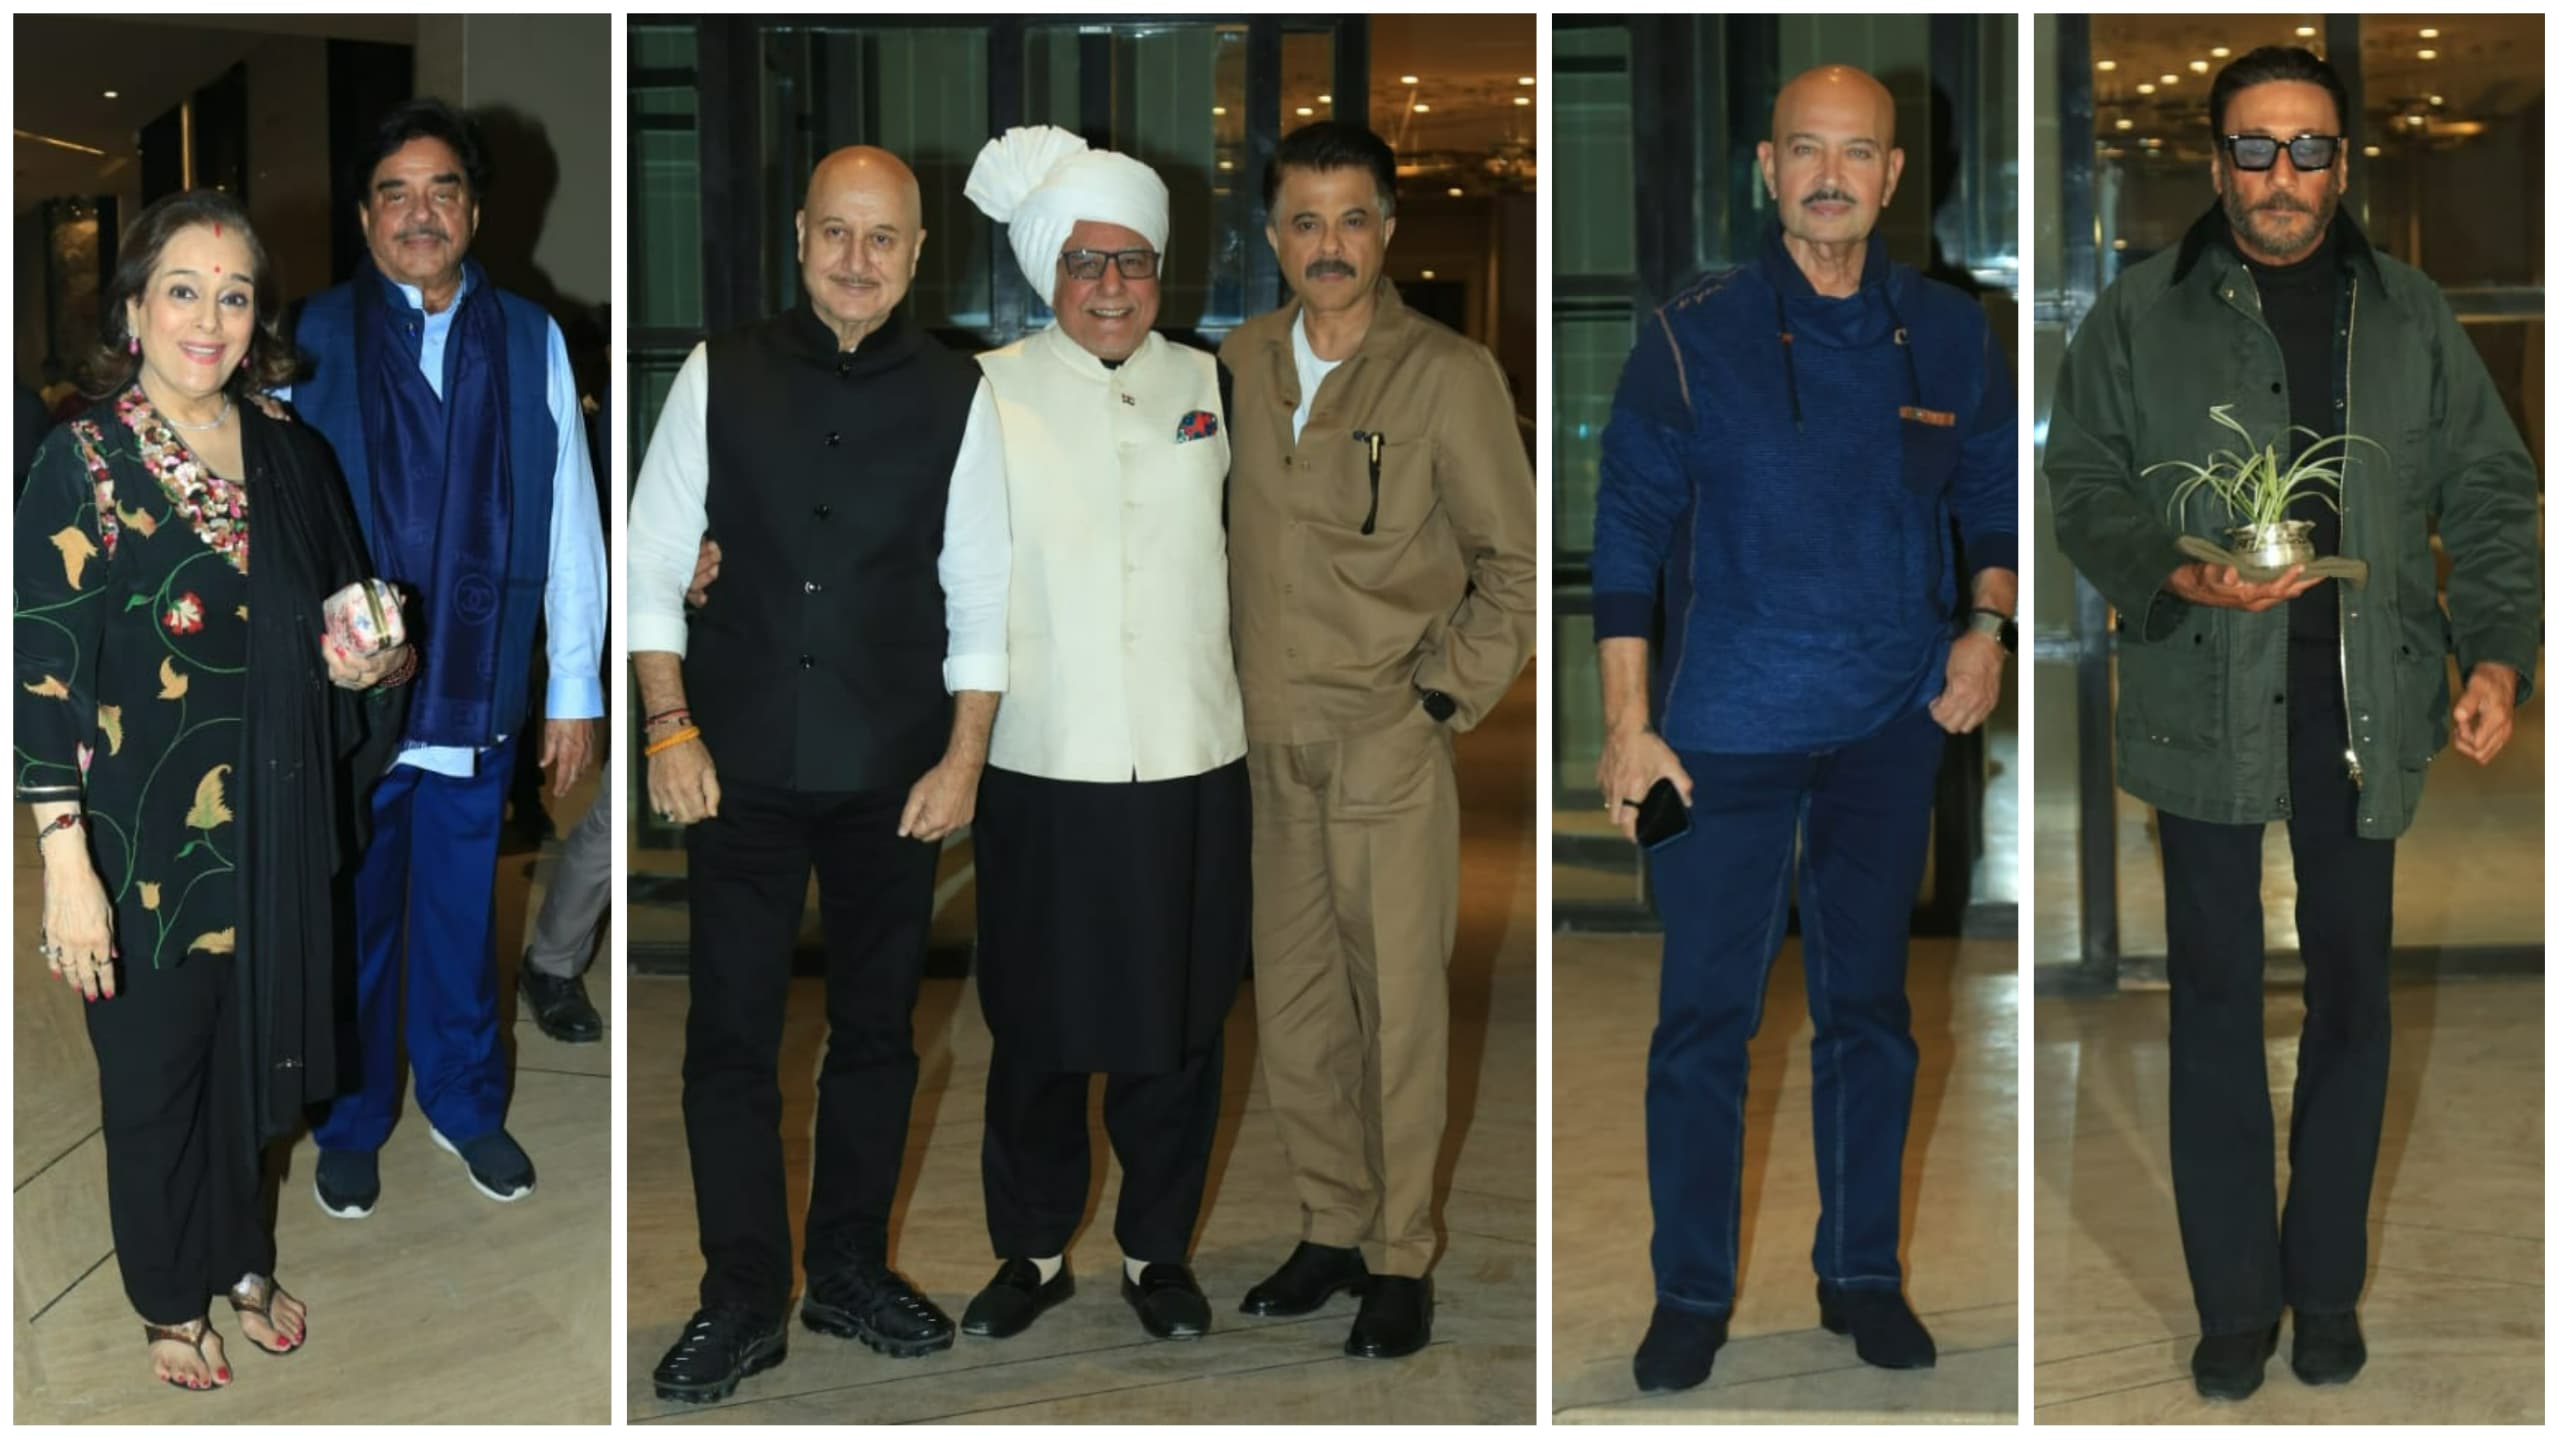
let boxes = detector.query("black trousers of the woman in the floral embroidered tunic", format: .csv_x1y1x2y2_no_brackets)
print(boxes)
87,952,276,1326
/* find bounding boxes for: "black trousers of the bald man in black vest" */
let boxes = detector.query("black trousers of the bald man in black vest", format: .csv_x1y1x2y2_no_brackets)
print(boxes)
684,783,940,1316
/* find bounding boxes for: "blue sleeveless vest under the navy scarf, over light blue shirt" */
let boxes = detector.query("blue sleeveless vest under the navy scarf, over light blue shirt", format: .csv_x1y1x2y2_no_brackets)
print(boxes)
294,271,561,735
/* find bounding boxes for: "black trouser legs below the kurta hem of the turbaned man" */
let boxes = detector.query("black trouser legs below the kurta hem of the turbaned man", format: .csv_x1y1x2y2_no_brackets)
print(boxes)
978,1037,1226,1264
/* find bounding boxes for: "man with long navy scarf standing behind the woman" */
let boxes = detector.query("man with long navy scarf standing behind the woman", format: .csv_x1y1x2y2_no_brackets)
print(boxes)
292,100,604,1218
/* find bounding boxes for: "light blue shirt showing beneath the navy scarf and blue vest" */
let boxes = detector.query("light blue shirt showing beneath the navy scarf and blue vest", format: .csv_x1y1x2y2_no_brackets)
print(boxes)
276,271,604,776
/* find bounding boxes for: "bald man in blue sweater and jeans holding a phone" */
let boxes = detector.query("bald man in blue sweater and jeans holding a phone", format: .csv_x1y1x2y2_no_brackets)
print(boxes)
1592,67,2017,1390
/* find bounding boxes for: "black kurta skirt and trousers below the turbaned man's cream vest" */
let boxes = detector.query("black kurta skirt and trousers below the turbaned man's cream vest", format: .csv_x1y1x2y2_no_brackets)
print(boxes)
975,763,1252,1262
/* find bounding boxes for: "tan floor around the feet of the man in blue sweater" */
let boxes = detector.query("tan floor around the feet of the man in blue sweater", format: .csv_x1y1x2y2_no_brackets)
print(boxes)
1551,937,2017,1426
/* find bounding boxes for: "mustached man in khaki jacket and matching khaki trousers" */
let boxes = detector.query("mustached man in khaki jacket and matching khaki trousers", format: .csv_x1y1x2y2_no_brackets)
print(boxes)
1219,120,1539,1357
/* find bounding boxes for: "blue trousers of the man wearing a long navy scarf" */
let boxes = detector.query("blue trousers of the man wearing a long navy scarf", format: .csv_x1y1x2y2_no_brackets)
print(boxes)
312,747,515,1152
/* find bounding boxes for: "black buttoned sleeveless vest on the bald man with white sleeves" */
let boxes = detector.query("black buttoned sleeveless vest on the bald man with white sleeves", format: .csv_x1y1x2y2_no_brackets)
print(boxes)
684,302,978,791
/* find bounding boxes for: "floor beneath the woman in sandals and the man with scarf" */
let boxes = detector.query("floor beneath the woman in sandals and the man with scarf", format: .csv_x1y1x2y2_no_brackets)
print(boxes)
10,781,612,1426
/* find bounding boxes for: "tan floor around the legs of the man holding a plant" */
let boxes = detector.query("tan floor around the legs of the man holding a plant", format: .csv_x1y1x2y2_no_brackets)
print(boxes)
2035,978,2542,1426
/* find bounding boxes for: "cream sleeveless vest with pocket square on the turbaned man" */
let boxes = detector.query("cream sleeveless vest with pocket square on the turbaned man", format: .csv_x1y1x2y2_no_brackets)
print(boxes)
978,325,1244,781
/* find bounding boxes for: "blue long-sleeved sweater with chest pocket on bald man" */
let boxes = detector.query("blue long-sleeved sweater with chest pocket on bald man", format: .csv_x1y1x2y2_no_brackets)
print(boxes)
1592,225,2017,752
